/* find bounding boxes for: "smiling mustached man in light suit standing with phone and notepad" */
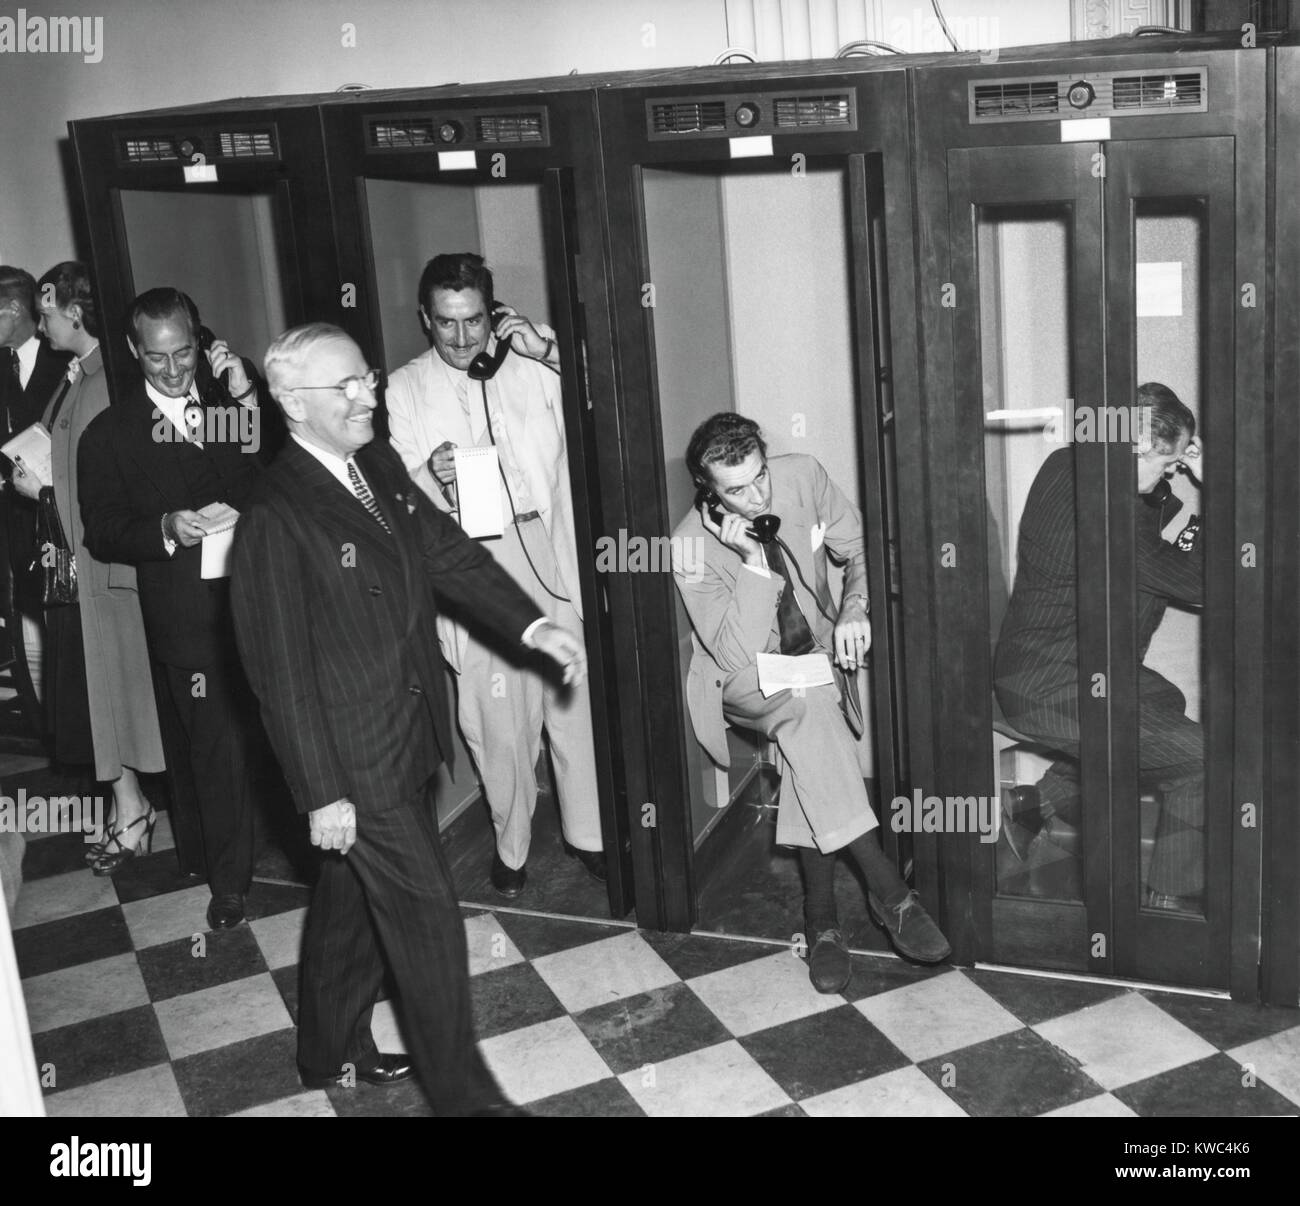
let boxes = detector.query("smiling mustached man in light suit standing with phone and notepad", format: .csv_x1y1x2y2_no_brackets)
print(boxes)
386,252,606,897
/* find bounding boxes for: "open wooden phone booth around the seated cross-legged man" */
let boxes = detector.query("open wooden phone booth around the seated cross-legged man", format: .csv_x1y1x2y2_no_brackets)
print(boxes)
601,64,933,942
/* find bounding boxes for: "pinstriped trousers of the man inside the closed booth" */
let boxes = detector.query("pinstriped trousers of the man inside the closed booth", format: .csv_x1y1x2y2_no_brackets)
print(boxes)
998,665,1205,897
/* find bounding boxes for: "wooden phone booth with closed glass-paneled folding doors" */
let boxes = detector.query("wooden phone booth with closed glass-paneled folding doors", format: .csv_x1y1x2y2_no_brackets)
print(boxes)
917,42,1264,993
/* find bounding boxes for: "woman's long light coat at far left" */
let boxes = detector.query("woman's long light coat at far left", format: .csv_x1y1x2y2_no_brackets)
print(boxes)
42,348,163,780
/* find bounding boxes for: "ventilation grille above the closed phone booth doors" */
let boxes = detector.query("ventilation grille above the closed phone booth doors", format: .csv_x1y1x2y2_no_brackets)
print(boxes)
967,68,1208,123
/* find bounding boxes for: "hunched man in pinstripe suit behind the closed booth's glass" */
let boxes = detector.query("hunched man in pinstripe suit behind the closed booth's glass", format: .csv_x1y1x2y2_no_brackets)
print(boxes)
993,382,1205,911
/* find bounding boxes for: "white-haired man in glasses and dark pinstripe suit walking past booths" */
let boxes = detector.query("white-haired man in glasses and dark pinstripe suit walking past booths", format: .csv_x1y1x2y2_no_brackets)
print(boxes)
231,324,585,1115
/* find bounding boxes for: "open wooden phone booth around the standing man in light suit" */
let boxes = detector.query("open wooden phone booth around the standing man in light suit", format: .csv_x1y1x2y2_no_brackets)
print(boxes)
321,84,641,916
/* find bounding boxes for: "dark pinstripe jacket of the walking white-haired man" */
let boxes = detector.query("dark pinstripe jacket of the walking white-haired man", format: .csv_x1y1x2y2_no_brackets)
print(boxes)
231,439,541,812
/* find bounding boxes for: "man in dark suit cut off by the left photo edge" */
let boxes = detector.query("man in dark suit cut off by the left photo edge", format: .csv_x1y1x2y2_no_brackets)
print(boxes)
0,265,70,717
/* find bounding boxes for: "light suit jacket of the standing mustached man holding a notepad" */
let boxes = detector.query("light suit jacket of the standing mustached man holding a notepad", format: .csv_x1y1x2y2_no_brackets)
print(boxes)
385,343,582,669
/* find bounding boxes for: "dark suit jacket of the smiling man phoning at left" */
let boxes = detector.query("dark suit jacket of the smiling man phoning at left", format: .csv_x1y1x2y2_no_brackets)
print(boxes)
78,378,260,668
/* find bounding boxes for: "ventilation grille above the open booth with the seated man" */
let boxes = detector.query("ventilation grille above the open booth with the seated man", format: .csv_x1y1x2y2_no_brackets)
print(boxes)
646,92,858,140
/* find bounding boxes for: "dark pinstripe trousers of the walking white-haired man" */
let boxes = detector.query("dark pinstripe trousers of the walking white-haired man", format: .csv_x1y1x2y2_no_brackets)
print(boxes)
298,791,503,1116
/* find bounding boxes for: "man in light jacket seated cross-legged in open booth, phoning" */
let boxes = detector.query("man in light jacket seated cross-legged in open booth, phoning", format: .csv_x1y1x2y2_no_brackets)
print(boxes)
672,412,950,993
